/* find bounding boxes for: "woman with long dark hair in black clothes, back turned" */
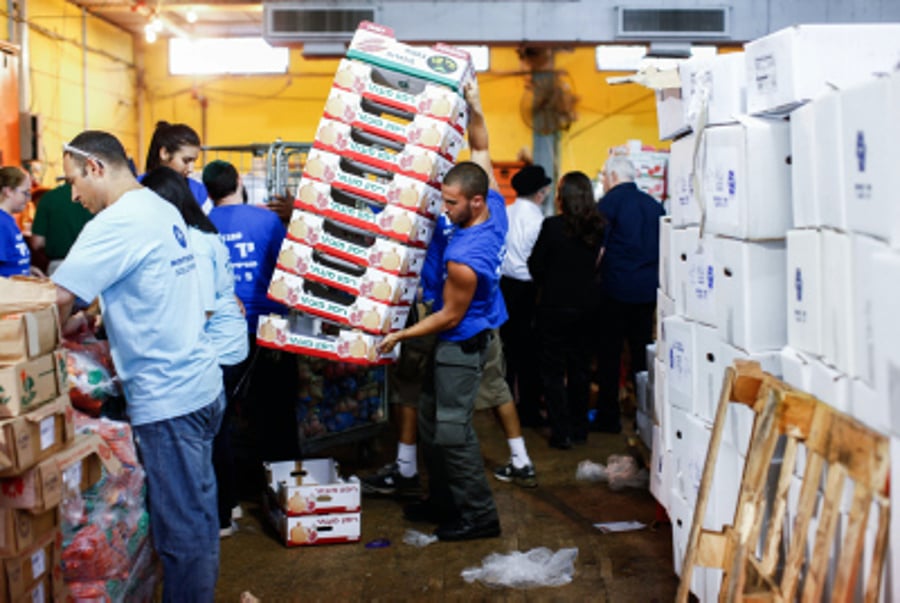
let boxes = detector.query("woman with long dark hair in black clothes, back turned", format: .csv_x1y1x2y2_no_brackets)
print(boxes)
528,172,605,450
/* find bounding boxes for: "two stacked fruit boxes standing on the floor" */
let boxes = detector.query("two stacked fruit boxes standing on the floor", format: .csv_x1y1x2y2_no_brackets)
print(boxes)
265,459,361,546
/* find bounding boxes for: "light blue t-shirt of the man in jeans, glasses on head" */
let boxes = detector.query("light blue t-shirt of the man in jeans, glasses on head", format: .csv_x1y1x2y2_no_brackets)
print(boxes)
53,188,222,425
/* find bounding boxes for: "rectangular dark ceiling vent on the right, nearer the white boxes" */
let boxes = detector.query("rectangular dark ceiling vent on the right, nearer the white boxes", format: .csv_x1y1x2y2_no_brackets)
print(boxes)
616,6,731,40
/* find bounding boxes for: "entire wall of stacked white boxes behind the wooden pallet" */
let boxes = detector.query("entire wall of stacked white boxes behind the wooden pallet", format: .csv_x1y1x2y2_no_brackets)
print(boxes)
651,25,900,600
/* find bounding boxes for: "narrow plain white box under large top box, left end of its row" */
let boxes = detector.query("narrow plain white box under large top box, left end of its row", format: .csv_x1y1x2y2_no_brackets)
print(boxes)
790,102,820,228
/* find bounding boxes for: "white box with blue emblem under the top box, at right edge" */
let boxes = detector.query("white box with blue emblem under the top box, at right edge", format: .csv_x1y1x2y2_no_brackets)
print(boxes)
841,78,898,240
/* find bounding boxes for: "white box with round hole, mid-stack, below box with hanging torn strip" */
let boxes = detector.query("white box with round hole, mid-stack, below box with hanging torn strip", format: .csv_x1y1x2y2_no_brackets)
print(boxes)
713,237,787,352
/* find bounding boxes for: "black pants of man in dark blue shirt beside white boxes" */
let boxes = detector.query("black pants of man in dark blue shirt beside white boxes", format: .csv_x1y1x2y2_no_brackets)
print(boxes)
595,297,656,431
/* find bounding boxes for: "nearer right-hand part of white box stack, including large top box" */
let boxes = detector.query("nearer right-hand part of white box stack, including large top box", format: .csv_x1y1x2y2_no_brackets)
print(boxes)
746,25,900,600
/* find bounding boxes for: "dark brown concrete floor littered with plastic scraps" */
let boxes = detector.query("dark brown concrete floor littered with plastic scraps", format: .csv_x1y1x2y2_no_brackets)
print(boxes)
216,412,678,602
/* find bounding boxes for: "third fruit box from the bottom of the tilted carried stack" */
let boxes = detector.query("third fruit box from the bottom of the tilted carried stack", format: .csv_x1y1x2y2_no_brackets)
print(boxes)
277,239,419,305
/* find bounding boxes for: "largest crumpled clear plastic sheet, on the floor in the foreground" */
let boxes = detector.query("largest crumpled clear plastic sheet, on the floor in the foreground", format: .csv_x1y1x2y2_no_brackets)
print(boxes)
462,547,578,588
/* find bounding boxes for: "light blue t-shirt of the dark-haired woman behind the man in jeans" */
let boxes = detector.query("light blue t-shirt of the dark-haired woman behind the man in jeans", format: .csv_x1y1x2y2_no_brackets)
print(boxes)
188,228,250,366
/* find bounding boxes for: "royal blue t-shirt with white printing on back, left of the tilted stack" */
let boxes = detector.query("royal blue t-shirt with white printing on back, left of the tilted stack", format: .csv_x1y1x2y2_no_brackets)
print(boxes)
209,205,287,334
